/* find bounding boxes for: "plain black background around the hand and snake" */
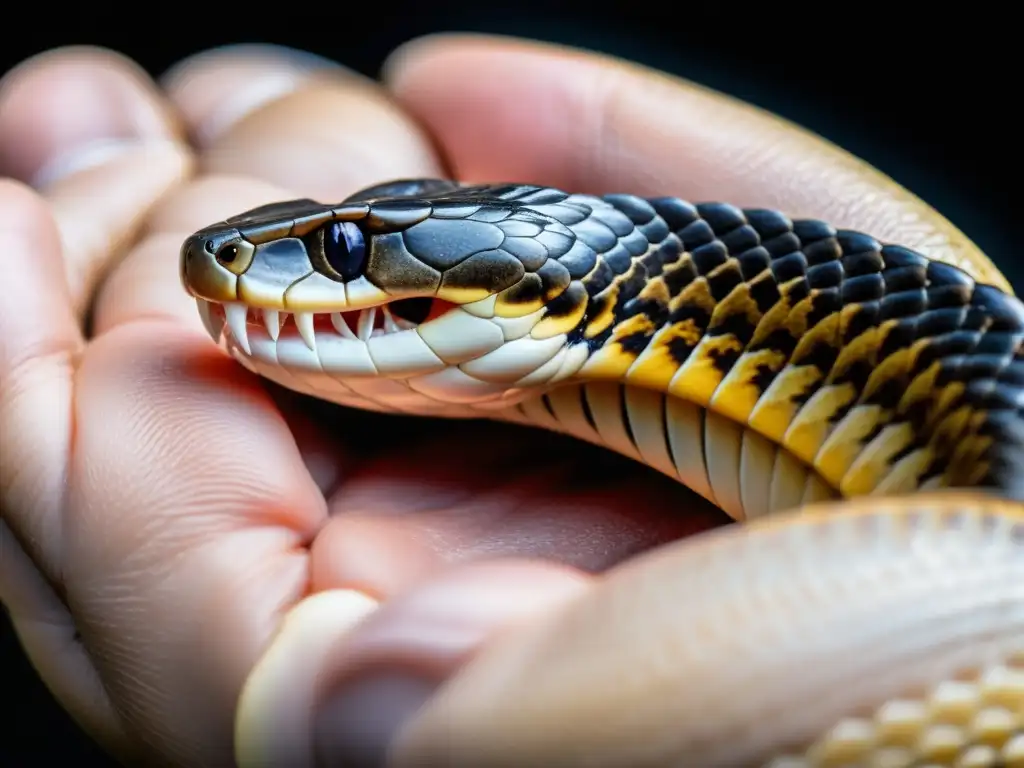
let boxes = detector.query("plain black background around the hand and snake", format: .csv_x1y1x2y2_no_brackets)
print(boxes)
0,6,1024,768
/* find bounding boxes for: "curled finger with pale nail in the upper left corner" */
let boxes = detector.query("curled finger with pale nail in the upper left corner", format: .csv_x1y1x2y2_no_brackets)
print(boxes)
0,48,190,317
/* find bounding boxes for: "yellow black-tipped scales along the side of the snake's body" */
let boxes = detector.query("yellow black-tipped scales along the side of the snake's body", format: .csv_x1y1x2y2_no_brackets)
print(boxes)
558,240,988,506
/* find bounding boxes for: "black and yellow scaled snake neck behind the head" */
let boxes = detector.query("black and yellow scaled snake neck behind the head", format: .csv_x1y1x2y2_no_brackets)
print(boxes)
485,196,1024,519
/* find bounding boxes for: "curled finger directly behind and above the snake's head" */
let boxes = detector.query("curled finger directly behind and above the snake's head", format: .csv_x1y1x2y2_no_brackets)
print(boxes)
161,48,441,200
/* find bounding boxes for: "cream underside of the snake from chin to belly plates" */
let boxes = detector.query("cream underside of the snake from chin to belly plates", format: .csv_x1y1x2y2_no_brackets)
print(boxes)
227,331,839,520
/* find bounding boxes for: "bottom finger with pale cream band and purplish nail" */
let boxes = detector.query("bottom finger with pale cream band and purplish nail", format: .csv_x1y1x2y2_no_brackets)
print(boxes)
236,562,587,767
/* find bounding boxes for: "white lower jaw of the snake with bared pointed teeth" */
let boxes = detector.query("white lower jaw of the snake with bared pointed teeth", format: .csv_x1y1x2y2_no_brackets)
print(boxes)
197,290,573,418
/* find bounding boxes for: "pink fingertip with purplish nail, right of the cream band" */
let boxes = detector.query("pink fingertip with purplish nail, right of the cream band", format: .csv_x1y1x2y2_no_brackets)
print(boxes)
311,562,584,768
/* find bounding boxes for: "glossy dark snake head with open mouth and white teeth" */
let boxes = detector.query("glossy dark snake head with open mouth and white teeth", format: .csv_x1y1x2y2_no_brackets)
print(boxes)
180,179,597,411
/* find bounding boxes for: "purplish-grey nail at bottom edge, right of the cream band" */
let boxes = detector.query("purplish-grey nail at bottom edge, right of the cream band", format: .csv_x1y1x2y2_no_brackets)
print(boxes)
313,672,437,768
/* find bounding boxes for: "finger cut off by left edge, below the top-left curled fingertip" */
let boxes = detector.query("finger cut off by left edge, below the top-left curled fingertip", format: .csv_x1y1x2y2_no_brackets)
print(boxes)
0,180,83,583
